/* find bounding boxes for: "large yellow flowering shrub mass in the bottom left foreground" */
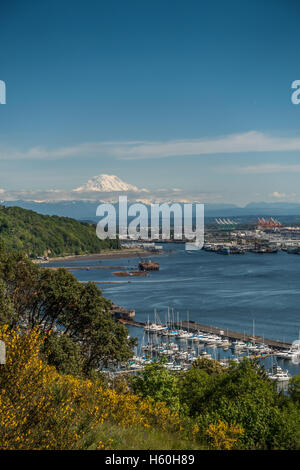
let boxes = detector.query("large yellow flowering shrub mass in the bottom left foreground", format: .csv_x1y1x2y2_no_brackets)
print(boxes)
0,326,180,449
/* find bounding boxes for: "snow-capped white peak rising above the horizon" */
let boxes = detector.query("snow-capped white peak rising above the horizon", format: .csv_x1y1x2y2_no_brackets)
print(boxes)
74,175,141,193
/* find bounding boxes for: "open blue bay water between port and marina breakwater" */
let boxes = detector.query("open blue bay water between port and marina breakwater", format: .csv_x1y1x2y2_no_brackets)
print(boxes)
50,244,300,373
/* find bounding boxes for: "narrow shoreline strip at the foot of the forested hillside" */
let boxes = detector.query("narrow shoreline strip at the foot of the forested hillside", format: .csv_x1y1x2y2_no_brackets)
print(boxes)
33,248,161,264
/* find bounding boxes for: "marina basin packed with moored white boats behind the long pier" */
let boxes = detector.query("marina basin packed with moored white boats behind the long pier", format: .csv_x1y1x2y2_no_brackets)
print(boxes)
106,320,300,391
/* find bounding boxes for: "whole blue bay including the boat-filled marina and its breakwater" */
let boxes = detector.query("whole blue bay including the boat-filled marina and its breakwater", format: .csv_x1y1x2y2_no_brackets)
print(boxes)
45,244,300,380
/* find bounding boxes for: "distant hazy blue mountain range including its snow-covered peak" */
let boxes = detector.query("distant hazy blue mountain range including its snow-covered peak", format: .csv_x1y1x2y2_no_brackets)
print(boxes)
0,173,300,221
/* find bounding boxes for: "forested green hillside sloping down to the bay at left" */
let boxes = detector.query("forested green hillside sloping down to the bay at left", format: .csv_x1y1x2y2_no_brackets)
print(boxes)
0,206,119,258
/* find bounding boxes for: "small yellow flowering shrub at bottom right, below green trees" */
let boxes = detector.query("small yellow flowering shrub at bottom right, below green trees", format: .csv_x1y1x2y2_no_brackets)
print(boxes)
205,420,244,450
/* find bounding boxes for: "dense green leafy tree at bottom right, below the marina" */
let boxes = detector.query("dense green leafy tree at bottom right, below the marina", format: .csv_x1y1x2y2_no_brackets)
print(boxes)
179,359,300,449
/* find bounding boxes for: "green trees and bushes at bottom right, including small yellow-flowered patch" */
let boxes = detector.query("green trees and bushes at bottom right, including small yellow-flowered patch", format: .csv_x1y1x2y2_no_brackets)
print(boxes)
132,359,300,449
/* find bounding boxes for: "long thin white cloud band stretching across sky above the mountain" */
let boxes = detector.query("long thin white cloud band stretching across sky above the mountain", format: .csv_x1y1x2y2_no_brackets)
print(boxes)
0,131,300,160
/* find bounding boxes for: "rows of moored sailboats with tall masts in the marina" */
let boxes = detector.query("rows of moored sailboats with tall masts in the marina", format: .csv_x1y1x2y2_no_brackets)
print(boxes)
114,310,300,386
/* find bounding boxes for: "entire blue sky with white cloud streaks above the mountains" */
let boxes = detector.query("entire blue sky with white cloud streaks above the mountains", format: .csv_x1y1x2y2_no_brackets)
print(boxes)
0,0,300,204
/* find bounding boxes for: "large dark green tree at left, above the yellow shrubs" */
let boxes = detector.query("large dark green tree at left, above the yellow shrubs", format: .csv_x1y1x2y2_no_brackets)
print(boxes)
0,245,133,373
